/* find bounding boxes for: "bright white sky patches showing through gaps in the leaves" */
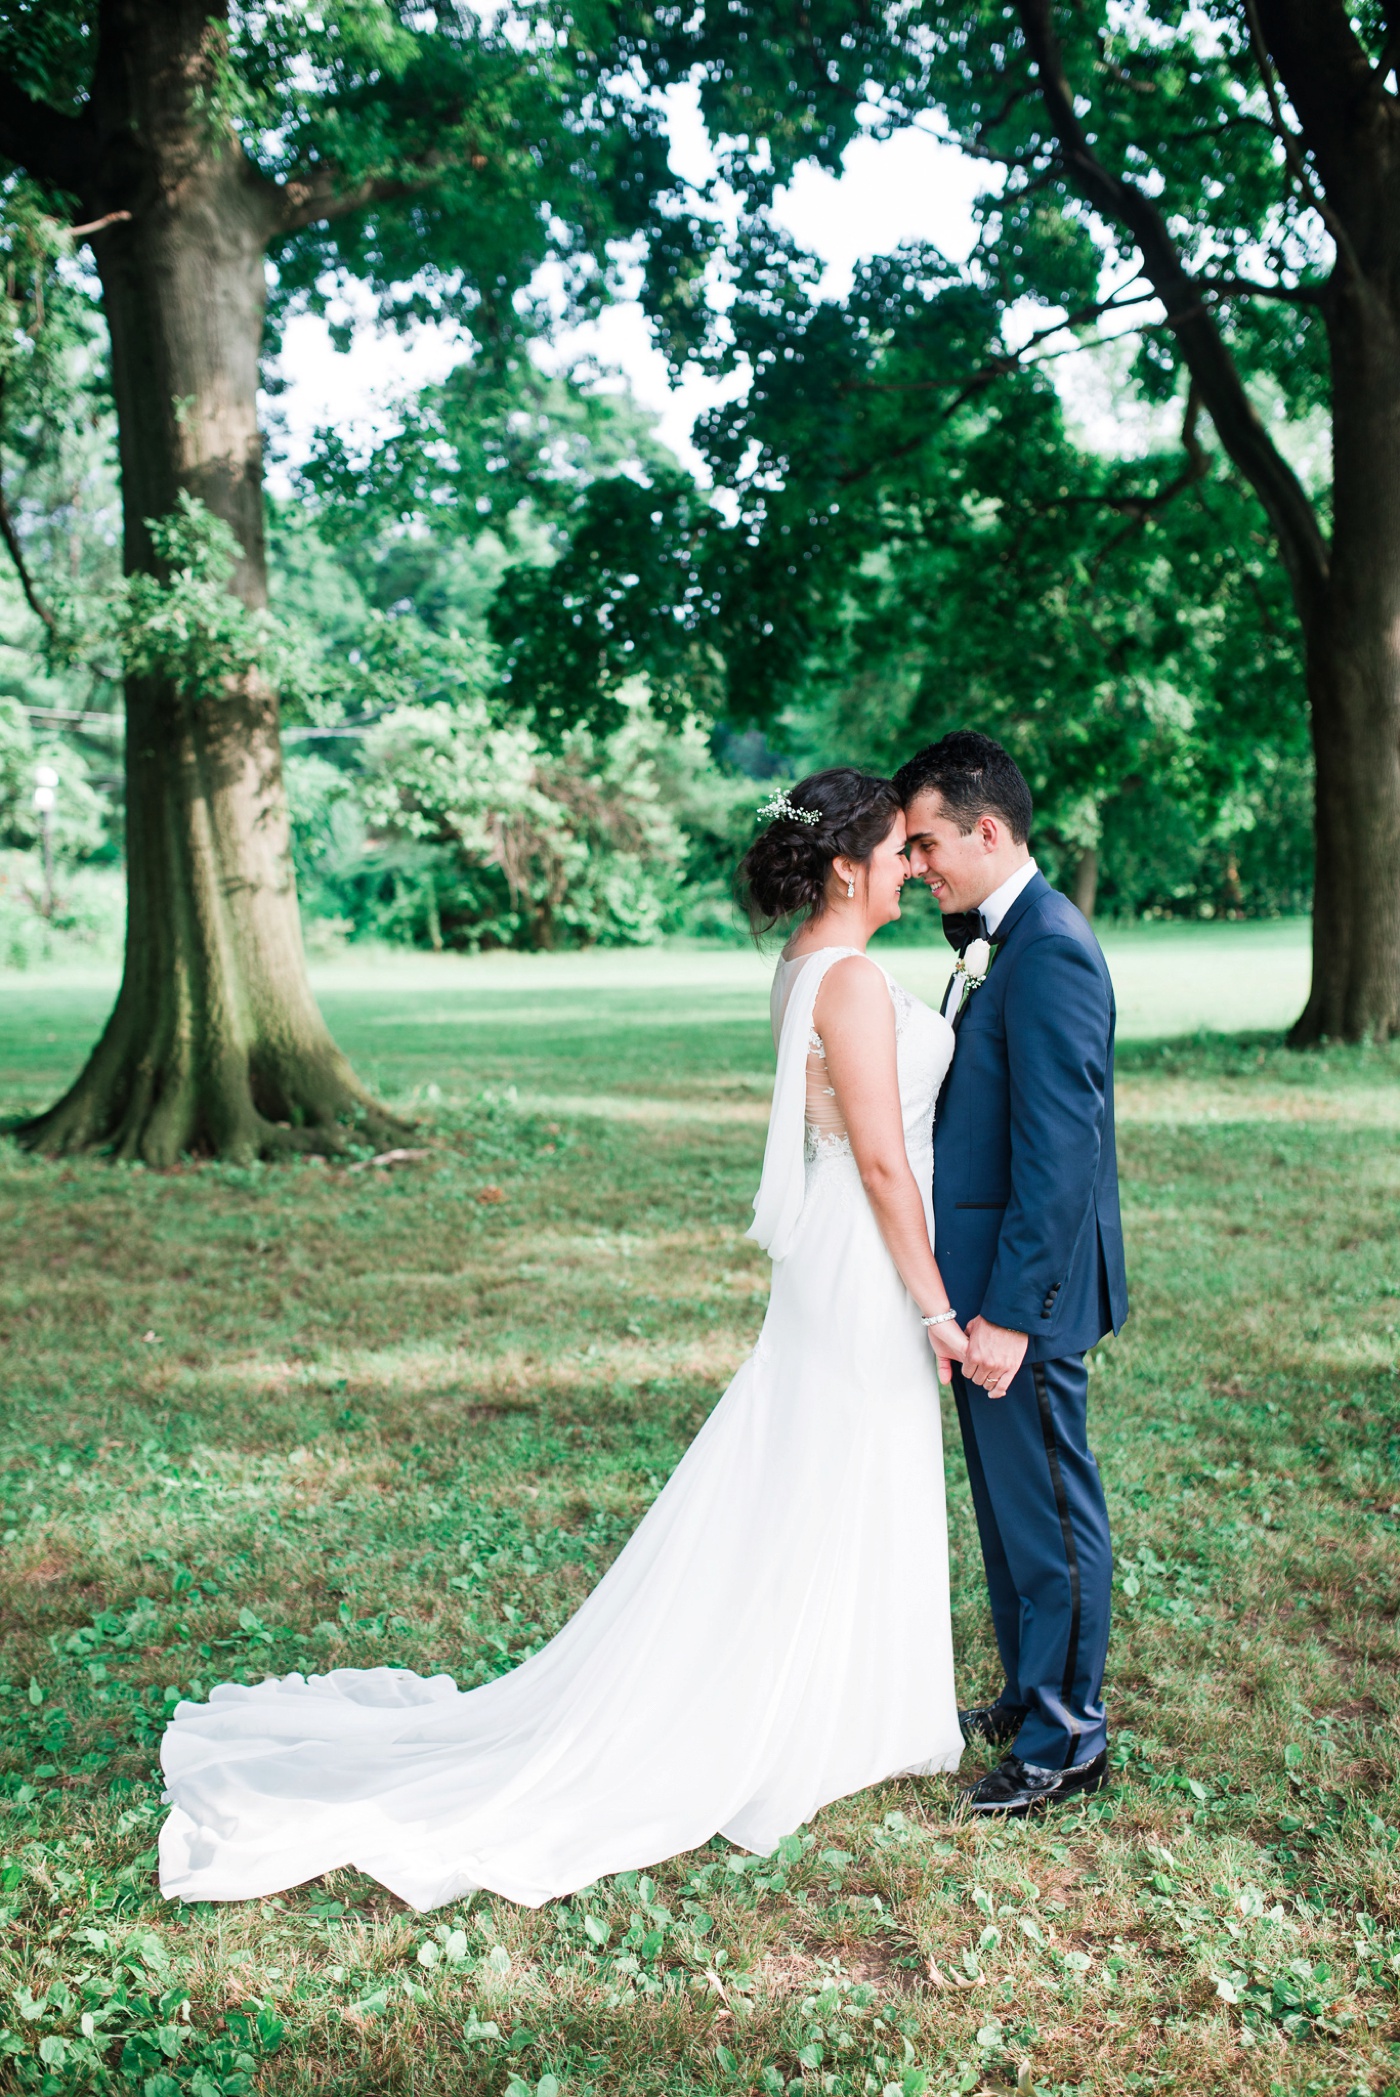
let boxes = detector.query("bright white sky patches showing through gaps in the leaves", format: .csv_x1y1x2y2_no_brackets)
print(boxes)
268,90,1173,491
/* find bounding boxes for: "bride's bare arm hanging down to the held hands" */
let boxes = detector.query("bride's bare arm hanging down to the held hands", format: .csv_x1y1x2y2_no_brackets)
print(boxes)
813,954,968,1382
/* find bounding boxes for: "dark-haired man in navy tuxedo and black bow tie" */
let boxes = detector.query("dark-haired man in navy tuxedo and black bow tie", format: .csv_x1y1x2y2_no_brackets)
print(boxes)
895,730,1128,1814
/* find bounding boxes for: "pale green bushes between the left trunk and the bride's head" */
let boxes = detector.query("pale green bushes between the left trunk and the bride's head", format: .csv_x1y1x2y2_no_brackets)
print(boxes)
287,692,752,948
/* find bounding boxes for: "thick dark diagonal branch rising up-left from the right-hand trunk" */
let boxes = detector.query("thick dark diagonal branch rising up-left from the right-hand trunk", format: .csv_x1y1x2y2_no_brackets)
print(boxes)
1016,0,1329,627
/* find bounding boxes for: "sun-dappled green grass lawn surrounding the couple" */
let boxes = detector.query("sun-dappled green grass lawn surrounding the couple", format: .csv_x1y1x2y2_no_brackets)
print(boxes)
0,925,1400,2097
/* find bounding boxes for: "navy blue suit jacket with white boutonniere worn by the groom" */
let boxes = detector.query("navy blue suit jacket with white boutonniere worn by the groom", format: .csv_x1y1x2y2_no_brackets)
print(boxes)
933,874,1128,1361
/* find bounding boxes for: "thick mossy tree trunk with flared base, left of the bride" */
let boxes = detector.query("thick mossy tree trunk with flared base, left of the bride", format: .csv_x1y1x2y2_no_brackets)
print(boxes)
23,12,402,1166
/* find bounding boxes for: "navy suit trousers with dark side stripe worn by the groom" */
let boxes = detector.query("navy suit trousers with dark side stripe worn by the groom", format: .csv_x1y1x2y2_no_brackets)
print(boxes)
954,1355,1113,1770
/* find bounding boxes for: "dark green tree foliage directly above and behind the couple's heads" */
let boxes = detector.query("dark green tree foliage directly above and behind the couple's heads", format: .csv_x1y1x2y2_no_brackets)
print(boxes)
493,241,1310,912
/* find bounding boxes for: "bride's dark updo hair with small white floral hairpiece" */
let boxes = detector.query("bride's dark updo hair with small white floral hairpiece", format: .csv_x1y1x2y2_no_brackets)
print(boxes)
740,765,903,931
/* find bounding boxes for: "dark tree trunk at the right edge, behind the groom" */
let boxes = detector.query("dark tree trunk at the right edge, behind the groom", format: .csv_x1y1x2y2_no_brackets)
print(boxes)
1291,285,1400,1046
